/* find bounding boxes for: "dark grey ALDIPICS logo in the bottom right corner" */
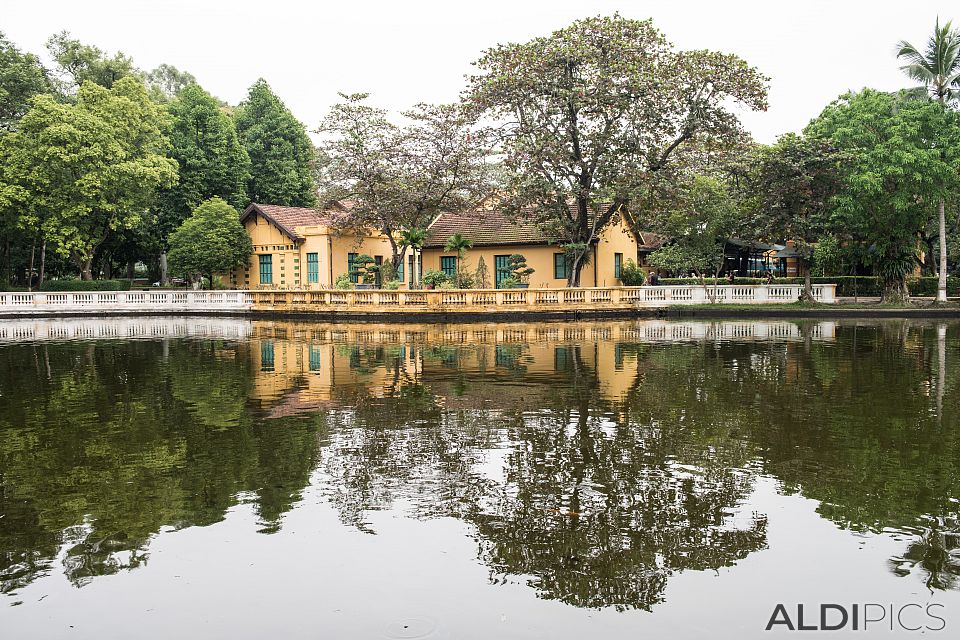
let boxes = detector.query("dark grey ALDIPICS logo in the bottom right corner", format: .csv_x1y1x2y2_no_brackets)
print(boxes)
766,602,947,633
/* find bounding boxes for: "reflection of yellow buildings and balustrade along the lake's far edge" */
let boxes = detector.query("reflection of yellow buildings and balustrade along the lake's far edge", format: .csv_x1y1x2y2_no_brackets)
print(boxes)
249,321,836,415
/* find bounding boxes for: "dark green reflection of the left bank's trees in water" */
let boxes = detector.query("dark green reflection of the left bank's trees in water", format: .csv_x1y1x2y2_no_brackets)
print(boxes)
0,341,318,592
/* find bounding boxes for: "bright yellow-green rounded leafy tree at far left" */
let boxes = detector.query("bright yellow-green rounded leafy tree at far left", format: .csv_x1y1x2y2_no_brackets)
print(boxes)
3,78,177,280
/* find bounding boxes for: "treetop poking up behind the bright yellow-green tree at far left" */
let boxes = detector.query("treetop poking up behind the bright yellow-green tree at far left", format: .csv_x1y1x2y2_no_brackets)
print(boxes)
47,31,141,95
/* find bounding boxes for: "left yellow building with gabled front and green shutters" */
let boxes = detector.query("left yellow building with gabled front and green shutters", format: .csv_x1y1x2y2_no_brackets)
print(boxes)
228,202,392,289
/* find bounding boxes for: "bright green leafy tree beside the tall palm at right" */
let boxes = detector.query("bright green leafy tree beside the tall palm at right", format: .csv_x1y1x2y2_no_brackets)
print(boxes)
804,89,960,302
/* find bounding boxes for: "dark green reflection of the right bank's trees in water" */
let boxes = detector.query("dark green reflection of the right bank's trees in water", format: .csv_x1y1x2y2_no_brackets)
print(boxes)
630,322,960,589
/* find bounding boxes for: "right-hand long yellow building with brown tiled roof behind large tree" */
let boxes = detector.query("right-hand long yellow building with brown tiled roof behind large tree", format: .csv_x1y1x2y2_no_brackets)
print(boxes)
423,205,659,289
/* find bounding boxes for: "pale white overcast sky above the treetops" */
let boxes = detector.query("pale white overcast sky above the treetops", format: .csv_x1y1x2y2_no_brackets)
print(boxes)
0,0,944,142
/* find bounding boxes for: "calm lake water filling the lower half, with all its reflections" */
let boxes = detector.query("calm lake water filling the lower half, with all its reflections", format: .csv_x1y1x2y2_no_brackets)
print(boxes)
0,318,960,639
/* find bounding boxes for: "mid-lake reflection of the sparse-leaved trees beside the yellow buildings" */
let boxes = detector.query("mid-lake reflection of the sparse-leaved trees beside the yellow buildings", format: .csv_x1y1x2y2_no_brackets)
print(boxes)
323,346,766,608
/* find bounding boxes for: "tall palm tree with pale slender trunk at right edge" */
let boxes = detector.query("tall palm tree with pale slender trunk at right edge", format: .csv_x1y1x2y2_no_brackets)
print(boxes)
897,18,960,302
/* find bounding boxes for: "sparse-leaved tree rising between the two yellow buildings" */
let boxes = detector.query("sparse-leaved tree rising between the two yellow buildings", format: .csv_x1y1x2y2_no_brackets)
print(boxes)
318,93,492,268
